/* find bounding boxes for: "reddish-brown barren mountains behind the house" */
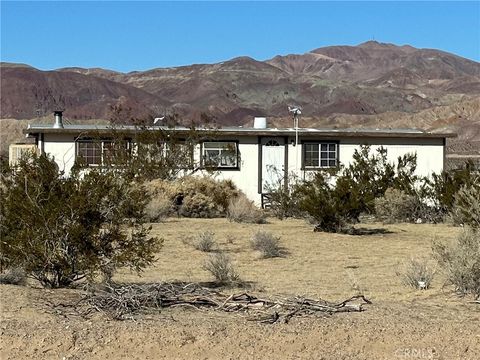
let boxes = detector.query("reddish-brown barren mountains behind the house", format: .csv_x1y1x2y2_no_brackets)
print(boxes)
0,41,480,148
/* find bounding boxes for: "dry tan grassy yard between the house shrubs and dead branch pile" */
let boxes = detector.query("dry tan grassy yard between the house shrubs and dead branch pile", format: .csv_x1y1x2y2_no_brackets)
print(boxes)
113,218,459,300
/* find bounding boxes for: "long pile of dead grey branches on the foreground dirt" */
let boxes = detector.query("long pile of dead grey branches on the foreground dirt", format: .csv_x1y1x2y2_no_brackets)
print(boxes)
85,283,371,323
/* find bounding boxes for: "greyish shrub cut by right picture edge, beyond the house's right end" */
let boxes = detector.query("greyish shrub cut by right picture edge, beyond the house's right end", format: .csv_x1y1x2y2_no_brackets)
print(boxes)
452,178,480,229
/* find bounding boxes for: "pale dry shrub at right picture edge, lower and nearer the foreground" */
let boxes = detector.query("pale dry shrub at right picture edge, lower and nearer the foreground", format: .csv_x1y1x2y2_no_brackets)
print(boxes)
433,227,480,298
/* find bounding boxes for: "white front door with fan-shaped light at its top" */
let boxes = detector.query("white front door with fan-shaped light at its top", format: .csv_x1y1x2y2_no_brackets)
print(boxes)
260,137,285,193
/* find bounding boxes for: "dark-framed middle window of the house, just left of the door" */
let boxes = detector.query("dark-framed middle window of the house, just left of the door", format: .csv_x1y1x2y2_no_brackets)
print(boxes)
203,141,238,168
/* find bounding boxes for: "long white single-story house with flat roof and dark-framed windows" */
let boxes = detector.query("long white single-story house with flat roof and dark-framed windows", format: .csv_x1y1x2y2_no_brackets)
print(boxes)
19,112,455,204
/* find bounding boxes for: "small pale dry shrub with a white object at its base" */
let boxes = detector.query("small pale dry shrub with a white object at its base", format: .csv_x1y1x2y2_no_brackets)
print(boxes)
397,258,435,289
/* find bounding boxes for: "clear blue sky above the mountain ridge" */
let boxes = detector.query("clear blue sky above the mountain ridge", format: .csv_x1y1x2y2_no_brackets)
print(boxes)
1,0,480,71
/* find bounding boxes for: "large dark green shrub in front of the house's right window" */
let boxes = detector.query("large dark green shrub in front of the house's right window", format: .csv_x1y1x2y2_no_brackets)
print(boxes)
295,146,416,232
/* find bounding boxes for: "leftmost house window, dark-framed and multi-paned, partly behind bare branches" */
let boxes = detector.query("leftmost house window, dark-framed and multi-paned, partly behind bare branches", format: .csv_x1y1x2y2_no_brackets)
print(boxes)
77,139,130,166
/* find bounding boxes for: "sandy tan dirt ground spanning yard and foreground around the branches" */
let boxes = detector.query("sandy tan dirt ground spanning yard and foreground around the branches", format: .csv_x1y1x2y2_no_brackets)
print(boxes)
0,219,480,360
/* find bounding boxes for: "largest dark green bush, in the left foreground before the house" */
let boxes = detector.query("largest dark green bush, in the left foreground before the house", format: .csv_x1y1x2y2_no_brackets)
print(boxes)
0,155,160,287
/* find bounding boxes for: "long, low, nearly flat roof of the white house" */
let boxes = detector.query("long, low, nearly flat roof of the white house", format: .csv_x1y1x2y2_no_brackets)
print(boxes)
23,125,457,138
